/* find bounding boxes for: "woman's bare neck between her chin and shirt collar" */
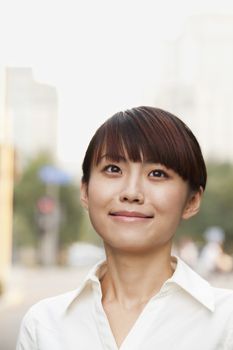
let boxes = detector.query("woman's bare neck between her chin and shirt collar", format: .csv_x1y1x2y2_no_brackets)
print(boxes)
101,245,174,308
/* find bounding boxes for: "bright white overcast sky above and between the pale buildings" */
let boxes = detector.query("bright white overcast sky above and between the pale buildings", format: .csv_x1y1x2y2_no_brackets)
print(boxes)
0,0,233,175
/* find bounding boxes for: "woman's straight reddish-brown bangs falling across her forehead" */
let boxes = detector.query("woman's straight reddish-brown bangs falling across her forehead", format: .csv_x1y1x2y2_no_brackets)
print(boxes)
94,111,187,177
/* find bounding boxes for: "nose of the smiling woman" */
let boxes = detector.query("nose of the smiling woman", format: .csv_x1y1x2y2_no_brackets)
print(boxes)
120,176,144,204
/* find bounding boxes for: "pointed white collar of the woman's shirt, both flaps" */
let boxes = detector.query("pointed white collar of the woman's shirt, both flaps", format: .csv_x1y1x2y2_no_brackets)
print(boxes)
65,256,215,312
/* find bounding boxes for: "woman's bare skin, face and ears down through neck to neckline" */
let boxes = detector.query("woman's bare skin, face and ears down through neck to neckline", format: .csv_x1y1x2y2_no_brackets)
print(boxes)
81,157,203,346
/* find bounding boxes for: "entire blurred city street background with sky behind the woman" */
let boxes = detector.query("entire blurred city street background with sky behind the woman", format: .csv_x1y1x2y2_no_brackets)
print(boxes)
0,0,233,350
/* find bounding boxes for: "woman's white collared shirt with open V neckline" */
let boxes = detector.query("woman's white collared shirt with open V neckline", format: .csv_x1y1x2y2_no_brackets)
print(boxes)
17,257,233,350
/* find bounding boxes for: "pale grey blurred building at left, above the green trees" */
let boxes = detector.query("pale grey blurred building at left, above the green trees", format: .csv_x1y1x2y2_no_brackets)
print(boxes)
6,67,58,165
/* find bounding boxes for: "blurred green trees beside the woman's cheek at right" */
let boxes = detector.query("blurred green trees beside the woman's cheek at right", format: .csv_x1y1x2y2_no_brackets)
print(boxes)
178,162,233,251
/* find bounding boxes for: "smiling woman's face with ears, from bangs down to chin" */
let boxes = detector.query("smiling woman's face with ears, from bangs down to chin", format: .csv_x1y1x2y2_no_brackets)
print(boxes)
81,157,201,252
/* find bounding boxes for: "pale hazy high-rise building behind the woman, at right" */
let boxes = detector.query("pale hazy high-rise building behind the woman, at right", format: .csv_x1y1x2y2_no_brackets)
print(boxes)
156,15,233,161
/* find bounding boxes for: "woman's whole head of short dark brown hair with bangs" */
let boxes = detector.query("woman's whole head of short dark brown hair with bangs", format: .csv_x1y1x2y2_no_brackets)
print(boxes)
82,106,207,191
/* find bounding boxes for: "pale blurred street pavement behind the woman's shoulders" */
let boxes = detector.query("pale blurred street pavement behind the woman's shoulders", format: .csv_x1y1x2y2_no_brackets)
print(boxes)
0,267,233,350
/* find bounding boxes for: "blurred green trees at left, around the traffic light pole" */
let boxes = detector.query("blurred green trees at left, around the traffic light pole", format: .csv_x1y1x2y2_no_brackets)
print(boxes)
13,153,82,253
